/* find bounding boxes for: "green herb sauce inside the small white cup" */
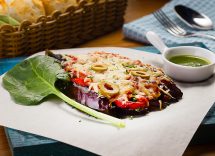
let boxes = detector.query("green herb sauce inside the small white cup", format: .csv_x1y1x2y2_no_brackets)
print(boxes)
169,55,210,67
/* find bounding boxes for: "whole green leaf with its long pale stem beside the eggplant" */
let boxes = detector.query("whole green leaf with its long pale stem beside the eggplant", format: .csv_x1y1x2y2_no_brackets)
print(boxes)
3,56,125,127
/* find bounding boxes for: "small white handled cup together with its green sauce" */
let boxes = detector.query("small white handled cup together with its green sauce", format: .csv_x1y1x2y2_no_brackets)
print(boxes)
146,31,215,82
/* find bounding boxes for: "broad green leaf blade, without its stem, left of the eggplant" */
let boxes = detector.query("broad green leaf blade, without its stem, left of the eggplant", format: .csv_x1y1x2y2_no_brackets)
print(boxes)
3,56,63,105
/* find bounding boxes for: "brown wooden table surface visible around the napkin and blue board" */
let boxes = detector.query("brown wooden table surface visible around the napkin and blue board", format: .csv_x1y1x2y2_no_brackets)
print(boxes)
0,0,215,156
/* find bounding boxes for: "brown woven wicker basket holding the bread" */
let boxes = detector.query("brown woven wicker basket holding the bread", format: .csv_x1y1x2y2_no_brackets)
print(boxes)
0,0,127,58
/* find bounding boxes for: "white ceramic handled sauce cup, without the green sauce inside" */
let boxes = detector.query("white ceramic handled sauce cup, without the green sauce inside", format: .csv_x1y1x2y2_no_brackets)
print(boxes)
146,31,215,82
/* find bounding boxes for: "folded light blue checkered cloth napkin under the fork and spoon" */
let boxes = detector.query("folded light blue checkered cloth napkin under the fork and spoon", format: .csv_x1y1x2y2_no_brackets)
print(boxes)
123,0,215,52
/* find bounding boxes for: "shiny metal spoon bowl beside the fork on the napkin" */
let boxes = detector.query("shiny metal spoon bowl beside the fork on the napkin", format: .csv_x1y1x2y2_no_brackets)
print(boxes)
174,5,213,30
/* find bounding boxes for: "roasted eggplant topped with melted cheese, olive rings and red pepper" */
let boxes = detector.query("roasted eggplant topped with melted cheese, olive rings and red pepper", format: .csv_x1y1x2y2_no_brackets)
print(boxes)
46,51,183,118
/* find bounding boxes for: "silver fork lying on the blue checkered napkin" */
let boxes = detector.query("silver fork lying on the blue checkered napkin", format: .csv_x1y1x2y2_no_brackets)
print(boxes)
153,10,215,40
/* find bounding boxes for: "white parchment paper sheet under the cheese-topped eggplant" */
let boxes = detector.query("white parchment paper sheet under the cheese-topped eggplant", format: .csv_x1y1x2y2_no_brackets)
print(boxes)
0,47,215,156
